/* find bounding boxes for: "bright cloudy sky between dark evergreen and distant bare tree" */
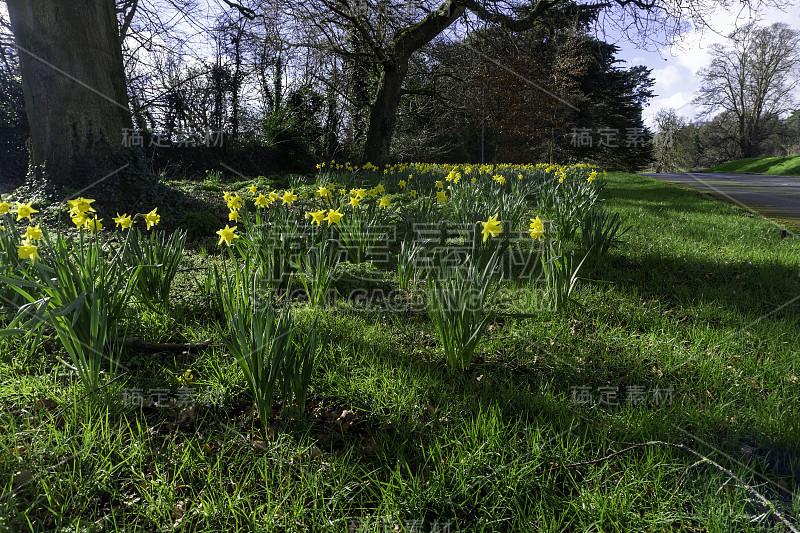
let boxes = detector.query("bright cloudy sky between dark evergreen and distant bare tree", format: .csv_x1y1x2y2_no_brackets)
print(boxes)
617,0,800,127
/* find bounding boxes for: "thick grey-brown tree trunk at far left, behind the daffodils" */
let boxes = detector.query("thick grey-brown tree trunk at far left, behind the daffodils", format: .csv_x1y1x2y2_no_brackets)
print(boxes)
7,0,131,194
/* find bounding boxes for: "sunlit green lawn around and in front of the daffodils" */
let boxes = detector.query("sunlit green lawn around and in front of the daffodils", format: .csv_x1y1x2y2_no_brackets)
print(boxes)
0,173,800,533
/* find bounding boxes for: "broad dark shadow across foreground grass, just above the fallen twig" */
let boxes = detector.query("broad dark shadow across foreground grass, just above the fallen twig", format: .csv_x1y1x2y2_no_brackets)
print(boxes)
302,304,800,516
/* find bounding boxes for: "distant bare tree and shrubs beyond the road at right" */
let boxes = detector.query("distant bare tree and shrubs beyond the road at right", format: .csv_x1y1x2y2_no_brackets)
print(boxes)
653,23,800,171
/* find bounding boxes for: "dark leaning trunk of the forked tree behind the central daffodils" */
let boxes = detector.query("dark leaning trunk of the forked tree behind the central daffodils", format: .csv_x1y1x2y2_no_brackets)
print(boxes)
362,59,408,167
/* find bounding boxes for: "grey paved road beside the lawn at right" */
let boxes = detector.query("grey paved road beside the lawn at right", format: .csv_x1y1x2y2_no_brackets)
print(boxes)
644,172,800,220
